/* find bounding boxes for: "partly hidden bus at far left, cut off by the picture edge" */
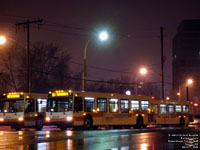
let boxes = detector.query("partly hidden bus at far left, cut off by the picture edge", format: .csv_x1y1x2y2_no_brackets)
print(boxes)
0,92,48,130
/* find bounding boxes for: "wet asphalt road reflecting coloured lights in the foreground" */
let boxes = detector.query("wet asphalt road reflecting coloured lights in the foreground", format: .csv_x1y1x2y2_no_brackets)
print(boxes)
0,126,200,150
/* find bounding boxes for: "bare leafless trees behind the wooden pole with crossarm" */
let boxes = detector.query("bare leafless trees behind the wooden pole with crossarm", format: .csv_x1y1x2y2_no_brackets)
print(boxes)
0,42,70,92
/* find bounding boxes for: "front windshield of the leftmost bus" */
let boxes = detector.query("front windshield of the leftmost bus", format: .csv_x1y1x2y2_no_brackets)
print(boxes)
2,99,24,113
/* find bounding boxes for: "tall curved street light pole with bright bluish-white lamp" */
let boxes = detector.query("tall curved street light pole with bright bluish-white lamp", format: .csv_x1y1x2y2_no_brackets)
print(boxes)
82,31,108,91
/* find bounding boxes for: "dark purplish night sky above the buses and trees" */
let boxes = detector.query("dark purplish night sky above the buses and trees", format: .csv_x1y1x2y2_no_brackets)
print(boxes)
0,0,200,95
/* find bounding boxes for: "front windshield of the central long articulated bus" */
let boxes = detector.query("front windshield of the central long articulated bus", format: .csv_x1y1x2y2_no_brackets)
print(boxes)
47,97,73,112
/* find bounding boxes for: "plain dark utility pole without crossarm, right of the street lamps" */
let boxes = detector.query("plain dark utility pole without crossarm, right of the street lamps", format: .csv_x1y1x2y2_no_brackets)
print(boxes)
160,27,165,100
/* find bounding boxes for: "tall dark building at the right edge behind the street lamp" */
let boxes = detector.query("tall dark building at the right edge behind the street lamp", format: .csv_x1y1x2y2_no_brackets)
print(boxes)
173,20,200,105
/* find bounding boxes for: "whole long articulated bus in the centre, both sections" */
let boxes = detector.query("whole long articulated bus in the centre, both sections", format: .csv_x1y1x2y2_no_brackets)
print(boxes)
45,90,193,129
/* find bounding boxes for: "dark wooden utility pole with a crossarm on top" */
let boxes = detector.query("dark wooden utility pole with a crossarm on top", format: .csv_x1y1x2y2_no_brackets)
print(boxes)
15,19,43,93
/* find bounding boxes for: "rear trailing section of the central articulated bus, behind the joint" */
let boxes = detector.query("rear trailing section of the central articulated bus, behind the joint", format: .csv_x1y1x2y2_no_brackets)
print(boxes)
151,100,194,126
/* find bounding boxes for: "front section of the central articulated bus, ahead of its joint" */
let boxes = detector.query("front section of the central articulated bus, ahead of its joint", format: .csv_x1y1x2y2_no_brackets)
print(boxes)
45,90,159,129
